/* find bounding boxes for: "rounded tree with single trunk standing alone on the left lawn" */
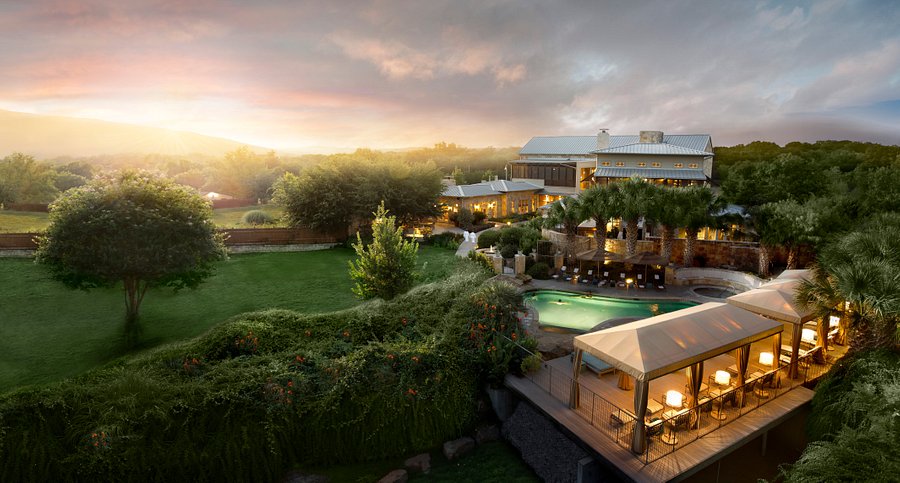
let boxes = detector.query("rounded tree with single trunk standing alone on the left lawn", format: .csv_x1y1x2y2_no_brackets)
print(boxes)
37,172,225,336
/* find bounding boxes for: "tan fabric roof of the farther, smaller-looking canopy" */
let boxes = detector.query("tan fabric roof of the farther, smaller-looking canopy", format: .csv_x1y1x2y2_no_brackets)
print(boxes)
727,280,815,324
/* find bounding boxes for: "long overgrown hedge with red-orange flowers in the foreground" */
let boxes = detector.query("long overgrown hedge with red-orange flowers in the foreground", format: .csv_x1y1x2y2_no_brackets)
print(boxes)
0,267,521,481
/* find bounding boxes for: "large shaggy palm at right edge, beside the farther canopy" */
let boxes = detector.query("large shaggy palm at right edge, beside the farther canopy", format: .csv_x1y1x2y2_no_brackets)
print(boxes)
797,220,900,349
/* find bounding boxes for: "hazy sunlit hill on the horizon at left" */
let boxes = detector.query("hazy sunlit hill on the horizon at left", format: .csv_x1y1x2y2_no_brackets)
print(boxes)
0,110,266,158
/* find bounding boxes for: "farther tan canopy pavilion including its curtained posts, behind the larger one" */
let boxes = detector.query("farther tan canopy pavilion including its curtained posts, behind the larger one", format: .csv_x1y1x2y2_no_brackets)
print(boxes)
727,270,816,377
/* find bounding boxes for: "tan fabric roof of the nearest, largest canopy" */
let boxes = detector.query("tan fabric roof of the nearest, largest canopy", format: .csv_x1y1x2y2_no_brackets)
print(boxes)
575,302,783,381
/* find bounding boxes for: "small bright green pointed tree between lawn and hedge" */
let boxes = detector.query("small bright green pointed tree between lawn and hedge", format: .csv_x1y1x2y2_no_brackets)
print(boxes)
350,203,419,300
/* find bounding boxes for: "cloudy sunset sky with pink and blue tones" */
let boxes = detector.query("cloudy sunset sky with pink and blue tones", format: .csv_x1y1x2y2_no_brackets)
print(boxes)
0,0,900,153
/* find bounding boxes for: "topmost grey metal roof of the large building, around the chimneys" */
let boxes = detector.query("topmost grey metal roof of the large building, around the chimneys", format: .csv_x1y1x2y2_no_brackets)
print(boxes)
519,134,713,156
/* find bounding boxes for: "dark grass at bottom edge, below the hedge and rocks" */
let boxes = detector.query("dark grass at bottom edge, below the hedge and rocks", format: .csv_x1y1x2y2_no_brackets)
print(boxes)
304,441,540,483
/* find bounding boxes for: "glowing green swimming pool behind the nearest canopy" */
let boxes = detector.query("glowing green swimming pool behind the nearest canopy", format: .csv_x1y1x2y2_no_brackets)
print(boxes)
524,290,697,332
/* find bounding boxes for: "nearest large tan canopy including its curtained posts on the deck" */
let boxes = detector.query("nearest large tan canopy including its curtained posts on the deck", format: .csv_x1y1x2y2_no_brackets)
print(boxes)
570,302,784,453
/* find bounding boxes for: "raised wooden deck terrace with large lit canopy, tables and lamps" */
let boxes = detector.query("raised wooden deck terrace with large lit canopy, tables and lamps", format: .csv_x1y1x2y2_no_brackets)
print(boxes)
506,303,828,481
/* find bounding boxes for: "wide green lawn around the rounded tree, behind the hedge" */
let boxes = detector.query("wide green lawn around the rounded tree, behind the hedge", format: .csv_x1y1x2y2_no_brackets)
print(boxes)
0,246,456,393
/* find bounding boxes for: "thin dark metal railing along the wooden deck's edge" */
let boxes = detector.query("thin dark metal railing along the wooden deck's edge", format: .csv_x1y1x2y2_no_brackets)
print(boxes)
520,347,830,464
